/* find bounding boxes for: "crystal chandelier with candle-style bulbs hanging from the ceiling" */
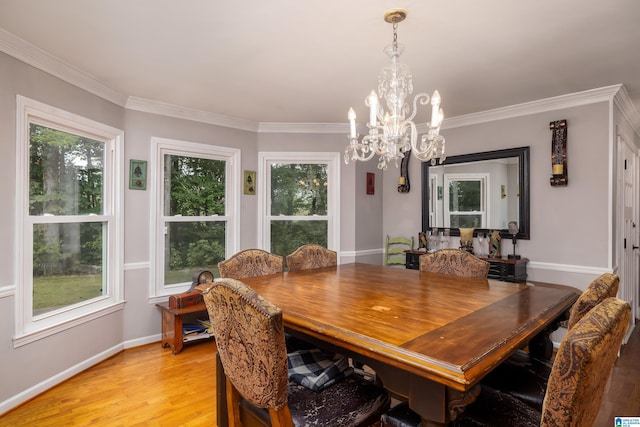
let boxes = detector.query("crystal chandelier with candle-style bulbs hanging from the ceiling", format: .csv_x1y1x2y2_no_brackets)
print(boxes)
344,9,445,170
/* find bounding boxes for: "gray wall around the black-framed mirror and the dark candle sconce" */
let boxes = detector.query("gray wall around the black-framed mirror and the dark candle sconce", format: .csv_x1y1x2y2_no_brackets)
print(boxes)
383,101,614,288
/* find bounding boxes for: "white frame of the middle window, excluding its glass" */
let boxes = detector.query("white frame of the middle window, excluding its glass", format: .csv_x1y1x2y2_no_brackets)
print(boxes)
149,137,242,303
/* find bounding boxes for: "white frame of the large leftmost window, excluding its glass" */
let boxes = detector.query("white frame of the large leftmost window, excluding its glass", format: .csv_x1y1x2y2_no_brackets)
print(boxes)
13,95,124,347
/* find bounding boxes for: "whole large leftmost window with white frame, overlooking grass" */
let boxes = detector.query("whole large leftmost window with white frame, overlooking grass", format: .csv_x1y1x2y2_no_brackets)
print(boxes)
15,96,123,346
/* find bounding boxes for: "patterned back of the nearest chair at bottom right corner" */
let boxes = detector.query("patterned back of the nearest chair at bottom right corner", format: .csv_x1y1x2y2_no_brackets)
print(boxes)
541,298,631,427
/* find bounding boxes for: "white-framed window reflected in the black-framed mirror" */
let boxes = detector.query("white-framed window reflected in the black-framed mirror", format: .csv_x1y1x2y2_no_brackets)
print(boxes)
444,173,489,228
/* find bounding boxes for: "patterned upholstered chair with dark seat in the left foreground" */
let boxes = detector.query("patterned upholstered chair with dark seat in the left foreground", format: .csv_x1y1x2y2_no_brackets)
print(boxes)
204,279,390,427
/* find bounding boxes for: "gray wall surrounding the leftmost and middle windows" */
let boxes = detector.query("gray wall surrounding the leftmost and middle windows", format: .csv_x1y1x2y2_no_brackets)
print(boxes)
0,53,257,413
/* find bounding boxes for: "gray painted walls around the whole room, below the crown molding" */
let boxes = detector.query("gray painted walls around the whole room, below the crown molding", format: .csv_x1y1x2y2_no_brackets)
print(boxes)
0,49,640,413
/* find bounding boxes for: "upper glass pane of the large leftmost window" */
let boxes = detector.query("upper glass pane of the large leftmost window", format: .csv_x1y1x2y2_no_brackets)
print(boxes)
29,123,105,215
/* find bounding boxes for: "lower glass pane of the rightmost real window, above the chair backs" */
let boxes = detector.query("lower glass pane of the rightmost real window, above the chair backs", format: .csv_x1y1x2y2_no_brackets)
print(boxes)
271,221,328,256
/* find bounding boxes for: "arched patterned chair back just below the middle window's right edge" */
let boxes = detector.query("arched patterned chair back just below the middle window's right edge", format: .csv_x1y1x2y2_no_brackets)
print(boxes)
218,249,284,279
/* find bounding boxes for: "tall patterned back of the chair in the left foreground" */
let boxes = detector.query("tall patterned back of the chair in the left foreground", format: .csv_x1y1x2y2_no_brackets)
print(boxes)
203,279,288,419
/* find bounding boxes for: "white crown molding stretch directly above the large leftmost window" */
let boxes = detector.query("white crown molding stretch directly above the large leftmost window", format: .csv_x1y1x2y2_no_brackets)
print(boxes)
0,28,127,107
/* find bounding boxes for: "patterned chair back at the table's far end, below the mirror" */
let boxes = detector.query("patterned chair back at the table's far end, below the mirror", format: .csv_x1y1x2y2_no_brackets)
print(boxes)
420,249,489,279
